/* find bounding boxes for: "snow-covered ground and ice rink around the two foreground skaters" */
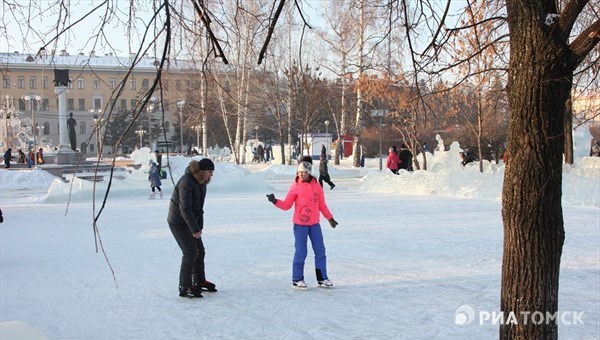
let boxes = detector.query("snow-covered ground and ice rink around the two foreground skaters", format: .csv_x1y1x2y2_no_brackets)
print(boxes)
0,144,600,340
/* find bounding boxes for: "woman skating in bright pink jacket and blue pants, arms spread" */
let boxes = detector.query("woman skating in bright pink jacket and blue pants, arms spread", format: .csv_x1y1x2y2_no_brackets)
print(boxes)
267,161,338,289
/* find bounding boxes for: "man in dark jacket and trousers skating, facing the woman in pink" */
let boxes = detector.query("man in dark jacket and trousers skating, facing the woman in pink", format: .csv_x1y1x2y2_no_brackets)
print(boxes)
167,158,217,297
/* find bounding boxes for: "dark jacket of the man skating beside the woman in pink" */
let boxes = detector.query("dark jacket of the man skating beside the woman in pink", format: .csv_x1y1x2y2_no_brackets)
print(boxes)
167,161,206,233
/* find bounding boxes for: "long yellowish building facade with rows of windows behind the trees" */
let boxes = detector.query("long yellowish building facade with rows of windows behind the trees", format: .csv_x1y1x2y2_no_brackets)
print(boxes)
0,51,202,156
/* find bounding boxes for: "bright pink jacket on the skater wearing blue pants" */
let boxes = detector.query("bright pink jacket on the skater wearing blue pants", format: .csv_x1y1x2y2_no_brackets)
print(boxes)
275,176,333,225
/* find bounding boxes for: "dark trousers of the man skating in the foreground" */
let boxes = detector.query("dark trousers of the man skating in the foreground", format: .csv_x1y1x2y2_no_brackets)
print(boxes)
169,224,206,288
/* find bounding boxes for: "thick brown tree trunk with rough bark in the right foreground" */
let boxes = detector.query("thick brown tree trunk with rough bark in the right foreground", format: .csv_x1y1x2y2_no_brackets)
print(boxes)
500,0,573,339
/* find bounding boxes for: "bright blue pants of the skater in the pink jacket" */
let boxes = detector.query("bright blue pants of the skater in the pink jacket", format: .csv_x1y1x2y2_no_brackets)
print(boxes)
292,223,327,281
